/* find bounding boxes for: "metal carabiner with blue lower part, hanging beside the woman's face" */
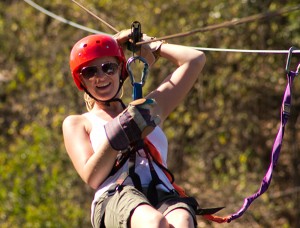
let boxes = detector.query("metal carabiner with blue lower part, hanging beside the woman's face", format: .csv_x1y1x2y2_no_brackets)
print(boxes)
126,56,149,100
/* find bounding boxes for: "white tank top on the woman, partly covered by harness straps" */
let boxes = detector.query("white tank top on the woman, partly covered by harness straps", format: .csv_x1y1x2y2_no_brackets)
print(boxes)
83,112,174,221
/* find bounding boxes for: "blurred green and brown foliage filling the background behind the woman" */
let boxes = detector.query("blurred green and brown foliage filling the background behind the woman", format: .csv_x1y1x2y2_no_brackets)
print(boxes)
0,0,300,227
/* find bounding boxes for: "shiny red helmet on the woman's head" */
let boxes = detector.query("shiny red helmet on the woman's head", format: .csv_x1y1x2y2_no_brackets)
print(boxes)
70,34,128,90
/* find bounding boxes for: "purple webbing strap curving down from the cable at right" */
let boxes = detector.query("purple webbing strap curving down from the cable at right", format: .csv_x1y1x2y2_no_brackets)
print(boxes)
227,68,298,222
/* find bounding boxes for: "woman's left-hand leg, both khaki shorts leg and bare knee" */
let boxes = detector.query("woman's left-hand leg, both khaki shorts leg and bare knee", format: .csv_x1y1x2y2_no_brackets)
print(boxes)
93,186,169,228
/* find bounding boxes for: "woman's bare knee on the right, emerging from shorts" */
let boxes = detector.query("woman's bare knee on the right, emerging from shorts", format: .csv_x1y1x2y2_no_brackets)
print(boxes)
166,208,195,228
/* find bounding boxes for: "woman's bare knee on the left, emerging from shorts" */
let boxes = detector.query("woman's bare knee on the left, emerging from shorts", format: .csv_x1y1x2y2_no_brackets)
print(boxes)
130,204,169,228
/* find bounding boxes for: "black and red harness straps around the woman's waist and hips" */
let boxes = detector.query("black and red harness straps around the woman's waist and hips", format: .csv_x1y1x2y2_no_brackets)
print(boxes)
100,135,224,221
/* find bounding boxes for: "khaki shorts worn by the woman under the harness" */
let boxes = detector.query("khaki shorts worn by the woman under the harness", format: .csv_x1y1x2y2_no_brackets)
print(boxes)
93,186,196,228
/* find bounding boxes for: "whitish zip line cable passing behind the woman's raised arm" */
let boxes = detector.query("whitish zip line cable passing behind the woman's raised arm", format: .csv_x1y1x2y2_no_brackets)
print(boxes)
24,0,300,54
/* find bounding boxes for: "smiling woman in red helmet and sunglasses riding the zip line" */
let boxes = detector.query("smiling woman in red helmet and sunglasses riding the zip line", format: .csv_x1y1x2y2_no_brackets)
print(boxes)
63,30,205,228
